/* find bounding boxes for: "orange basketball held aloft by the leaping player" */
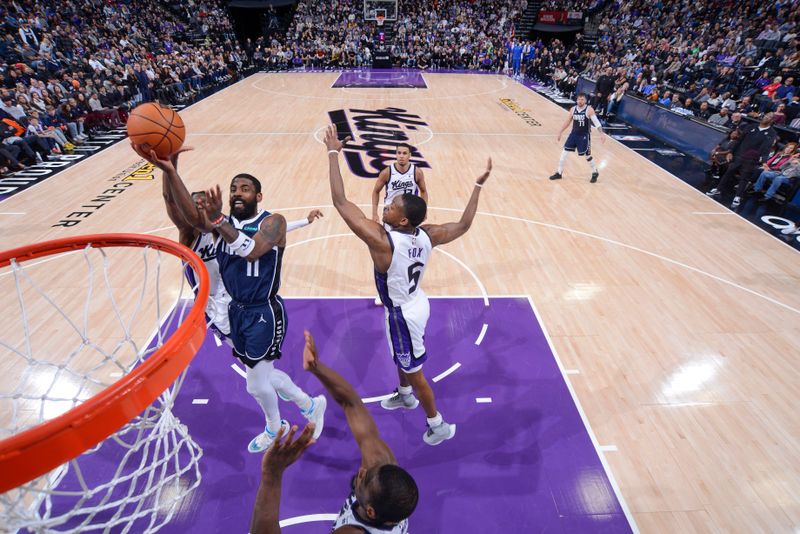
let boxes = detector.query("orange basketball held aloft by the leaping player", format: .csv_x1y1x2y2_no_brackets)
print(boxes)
127,102,186,158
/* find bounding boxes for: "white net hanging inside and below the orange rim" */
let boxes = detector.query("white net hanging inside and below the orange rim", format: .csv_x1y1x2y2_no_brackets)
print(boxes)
0,243,202,533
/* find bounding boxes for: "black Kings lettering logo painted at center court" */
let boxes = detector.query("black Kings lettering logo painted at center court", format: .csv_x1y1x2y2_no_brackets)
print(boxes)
328,107,431,178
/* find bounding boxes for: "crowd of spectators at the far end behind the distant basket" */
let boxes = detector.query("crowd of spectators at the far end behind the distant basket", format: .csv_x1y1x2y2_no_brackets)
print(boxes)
252,0,527,71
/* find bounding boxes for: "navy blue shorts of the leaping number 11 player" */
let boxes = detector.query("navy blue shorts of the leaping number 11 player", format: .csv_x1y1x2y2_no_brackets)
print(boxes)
228,297,288,367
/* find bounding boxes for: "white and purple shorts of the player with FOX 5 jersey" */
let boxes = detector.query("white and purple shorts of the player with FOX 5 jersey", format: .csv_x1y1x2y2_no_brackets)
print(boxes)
384,295,431,373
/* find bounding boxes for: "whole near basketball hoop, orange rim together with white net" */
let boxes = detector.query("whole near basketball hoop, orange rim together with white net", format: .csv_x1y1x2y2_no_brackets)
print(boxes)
0,234,209,532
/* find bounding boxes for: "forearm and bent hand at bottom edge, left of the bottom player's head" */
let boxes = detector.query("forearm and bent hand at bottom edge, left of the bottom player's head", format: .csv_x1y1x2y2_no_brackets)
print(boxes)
250,423,315,534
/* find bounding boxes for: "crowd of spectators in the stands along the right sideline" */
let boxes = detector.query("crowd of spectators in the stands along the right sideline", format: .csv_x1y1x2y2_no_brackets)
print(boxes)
521,0,800,213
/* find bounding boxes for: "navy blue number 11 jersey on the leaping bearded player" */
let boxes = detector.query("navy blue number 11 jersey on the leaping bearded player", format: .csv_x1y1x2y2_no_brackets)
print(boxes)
217,210,283,305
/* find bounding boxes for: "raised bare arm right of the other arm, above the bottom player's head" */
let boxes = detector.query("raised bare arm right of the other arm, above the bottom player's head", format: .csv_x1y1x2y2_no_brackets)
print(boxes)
303,330,397,468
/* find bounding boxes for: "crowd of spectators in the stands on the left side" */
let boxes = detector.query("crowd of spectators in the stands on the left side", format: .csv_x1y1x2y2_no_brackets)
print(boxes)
0,0,246,177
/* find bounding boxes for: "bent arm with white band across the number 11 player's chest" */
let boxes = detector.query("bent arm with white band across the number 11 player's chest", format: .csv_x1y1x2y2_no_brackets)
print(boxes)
203,185,286,261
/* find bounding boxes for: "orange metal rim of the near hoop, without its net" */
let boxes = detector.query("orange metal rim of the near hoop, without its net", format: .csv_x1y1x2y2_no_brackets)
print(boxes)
0,234,209,493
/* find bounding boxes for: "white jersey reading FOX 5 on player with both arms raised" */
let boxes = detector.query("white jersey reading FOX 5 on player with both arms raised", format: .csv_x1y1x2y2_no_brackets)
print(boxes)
375,228,433,308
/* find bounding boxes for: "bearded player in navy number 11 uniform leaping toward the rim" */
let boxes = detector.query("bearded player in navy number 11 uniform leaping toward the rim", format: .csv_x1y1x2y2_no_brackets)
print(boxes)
192,174,327,453
